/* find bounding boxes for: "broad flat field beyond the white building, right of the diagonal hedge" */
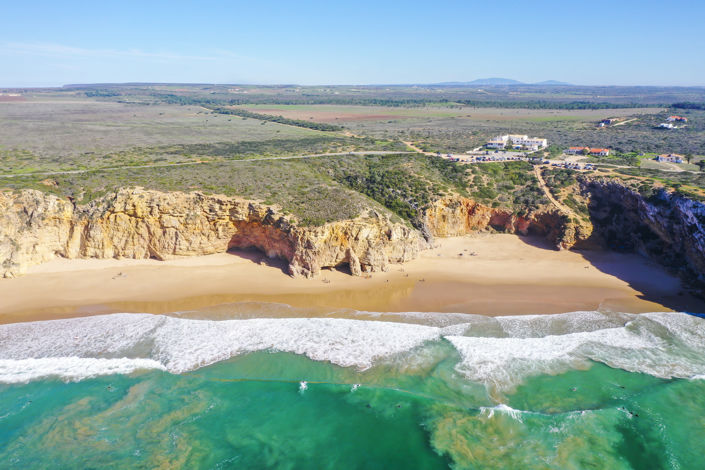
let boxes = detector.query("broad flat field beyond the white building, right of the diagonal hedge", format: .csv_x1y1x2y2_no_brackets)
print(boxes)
239,104,692,153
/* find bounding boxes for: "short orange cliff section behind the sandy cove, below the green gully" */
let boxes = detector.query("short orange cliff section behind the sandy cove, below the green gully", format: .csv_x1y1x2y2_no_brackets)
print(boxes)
421,197,590,249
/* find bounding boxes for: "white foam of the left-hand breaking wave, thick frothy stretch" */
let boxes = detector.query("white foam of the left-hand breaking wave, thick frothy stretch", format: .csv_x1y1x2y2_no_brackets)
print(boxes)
0,314,440,377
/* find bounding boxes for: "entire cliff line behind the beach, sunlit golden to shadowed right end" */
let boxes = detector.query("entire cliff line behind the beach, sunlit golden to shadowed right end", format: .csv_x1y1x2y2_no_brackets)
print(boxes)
5,176,705,282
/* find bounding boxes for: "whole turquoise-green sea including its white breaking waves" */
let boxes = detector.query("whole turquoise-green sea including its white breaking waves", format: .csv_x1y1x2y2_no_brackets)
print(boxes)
0,312,705,469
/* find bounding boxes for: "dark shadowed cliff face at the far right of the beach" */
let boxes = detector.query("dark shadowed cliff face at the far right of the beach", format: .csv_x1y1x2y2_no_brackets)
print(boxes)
580,178,705,282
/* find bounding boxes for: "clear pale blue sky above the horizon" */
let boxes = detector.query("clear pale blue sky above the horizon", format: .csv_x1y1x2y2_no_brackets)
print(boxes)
0,0,705,87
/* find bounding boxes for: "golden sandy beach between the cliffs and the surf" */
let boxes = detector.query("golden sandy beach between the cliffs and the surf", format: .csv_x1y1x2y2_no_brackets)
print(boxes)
0,233,703,323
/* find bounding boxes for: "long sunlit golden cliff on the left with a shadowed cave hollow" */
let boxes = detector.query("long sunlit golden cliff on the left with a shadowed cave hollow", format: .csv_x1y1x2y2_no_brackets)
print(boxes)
0,189,426,277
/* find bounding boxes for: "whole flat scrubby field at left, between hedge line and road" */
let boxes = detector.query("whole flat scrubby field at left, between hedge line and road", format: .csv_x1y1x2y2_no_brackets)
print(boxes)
0,94,404,174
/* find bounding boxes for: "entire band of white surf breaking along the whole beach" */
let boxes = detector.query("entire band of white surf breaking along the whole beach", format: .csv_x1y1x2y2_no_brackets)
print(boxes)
0,312,705,390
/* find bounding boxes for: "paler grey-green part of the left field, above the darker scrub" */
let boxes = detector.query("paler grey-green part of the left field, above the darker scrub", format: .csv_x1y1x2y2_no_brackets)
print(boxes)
0,99,317,156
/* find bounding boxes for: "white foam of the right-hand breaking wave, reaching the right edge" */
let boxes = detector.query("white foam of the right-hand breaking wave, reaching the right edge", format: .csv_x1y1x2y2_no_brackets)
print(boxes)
446,313,705,390
